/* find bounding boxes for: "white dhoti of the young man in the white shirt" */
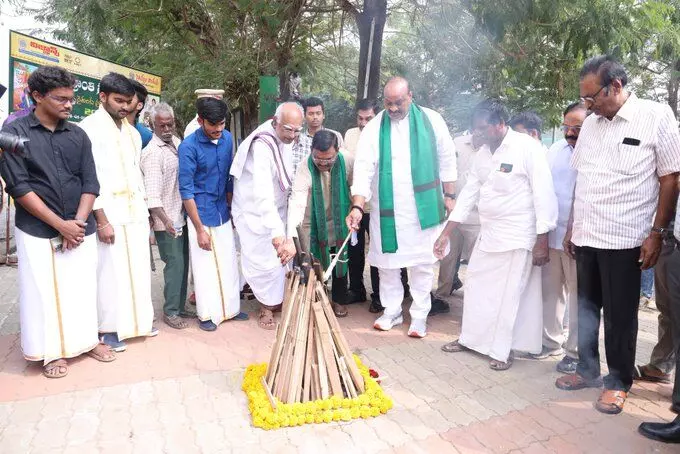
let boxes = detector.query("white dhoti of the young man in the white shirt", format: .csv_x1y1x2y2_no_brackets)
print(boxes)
97,222,153,340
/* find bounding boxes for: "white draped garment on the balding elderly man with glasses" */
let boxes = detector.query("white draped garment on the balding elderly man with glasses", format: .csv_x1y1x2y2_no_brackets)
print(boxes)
231,122,292,306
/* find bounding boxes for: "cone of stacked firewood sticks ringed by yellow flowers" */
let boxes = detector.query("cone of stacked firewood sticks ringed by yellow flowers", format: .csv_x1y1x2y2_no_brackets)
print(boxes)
263,263,364,408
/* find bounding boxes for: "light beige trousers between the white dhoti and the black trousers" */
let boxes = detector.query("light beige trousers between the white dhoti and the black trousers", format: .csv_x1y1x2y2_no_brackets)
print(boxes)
541,249,578,359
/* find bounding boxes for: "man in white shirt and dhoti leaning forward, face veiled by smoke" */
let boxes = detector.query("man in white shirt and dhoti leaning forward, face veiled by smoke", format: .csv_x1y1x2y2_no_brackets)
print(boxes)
434,99,557,370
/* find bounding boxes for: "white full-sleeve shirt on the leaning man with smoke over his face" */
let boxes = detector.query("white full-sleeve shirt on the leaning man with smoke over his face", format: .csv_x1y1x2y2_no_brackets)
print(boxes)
449,128,557,252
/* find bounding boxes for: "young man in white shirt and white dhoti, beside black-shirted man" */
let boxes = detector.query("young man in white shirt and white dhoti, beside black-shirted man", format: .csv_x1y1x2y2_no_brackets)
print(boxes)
80,73,158,352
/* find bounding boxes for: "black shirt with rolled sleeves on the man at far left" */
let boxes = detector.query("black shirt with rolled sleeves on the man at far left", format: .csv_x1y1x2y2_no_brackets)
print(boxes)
0,113,99,238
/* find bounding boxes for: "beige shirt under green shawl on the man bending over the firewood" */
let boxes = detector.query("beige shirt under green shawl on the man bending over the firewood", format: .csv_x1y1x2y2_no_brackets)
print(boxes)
287,152,354,242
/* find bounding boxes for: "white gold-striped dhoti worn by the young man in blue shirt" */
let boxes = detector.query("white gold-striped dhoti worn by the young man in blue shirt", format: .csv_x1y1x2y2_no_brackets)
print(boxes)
187,222,241,325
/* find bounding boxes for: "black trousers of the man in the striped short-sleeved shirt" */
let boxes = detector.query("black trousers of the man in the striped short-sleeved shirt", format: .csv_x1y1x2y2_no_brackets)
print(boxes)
576,247,640,391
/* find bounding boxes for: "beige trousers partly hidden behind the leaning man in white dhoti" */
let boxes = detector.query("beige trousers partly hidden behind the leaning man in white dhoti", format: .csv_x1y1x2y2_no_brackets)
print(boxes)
434,224,479,299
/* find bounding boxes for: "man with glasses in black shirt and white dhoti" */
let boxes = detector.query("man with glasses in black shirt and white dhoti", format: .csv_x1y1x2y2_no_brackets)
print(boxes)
0,66,116,378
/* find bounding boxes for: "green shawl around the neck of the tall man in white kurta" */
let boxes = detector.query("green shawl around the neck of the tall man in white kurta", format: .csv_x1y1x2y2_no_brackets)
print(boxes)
378,103,446,253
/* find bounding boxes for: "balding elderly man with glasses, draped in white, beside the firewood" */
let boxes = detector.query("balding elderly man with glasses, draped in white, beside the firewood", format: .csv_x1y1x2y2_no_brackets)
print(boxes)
231,102,304,329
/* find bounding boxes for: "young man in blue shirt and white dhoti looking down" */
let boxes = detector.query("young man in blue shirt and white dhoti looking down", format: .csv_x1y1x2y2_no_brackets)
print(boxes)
179,98,248,331
